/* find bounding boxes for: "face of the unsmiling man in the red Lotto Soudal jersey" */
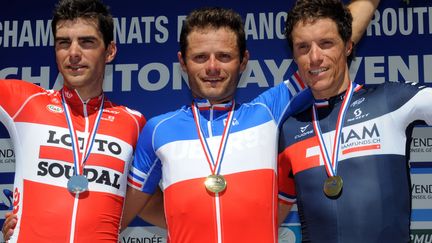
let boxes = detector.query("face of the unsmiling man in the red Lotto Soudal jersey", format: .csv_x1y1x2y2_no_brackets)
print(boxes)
55,18,116,94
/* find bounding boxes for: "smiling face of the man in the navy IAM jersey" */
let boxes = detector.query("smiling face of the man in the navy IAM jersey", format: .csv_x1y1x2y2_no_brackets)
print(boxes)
292,18,352,99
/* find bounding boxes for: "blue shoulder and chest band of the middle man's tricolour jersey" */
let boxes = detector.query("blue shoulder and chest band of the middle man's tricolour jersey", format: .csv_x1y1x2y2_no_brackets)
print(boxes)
149,80,311,151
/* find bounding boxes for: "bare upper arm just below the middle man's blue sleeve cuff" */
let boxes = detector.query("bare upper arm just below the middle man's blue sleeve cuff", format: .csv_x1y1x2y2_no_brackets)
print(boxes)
121,186,152,230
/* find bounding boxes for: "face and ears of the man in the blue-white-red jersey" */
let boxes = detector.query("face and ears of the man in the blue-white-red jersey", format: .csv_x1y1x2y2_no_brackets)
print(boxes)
178,28,249,104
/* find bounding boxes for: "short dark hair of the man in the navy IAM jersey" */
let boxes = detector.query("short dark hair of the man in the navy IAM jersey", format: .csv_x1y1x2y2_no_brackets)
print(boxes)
285,0,354,61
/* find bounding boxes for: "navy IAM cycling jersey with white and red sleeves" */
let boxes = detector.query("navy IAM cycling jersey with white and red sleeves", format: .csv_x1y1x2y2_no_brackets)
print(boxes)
279,83,432,243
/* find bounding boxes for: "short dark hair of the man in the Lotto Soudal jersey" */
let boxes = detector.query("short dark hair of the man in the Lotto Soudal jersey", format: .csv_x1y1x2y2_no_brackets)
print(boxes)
51,0,114,47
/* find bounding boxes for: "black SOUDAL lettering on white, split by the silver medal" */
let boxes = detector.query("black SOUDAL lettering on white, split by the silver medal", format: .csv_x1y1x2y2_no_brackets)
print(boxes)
37,161,121,189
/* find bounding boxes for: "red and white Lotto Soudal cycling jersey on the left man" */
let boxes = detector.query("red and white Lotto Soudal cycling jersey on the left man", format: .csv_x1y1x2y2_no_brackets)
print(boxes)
0,80,145,243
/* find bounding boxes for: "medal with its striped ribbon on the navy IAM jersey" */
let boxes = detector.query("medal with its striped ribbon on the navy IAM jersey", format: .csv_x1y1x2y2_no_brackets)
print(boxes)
312,82,357,198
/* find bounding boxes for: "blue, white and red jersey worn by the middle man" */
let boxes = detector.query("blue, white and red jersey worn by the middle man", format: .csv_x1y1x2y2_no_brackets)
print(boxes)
129,78,311,243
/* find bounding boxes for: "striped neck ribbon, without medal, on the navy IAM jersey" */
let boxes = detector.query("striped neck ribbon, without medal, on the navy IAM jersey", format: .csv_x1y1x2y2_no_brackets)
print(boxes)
312,82,358,177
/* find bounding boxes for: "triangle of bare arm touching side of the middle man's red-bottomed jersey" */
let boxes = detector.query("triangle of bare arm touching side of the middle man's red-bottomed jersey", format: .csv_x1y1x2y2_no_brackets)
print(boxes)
138,189,166,229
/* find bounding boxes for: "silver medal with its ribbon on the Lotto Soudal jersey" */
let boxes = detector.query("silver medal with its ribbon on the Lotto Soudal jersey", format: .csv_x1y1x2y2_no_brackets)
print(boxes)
62,90,104,195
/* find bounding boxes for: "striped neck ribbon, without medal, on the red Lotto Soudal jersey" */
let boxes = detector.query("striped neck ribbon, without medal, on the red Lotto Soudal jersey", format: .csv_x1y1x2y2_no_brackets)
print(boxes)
62,90,105,175
